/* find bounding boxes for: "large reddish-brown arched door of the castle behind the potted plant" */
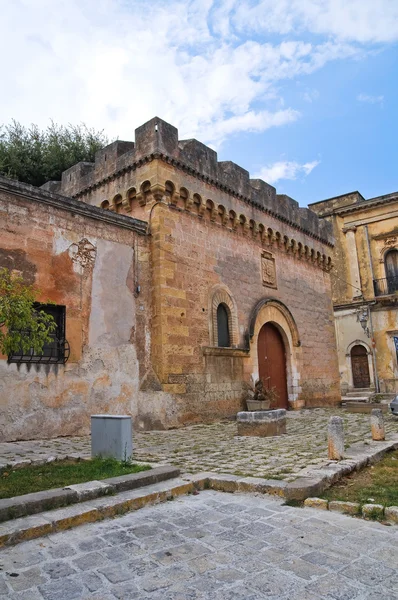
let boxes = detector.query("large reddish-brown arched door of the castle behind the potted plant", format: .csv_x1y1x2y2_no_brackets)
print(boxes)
257,323,288,408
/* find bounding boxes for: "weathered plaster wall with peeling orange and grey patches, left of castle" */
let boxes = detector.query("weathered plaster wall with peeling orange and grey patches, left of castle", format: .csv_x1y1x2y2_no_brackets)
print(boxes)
0,188,177,441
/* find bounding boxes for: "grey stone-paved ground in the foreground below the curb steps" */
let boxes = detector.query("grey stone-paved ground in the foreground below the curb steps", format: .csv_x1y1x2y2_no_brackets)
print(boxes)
0,491,398,600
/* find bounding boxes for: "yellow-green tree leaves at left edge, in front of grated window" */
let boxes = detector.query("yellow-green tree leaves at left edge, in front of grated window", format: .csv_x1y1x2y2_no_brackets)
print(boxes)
0,268,57,356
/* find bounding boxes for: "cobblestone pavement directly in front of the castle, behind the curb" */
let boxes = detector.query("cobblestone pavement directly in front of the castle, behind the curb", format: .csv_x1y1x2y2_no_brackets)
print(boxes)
0,409,398,480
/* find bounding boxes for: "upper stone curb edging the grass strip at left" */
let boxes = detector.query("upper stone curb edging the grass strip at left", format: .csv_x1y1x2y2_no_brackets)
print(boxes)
0,466,180,522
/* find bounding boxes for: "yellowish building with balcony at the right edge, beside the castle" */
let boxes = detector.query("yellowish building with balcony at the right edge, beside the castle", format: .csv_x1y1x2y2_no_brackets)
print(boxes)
310,192,398,394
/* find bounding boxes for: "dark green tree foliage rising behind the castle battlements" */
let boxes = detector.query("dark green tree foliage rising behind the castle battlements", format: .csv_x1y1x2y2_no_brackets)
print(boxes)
0,121,108,186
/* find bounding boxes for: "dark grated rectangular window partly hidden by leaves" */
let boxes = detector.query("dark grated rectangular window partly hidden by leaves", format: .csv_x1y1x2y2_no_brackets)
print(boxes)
8,303,70,364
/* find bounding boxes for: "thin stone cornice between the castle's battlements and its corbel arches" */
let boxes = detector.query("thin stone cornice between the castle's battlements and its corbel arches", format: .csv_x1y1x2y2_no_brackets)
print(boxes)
71,152,334,248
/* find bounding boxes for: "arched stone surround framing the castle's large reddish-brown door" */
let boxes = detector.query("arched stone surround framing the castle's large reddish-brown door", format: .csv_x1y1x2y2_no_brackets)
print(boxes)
249,298,304,409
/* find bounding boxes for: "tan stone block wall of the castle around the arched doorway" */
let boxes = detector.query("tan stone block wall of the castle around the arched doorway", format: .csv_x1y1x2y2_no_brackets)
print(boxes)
148,195,340,422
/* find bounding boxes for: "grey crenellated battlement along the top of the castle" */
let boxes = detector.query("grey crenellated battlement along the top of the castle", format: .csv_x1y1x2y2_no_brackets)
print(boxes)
43,117,333,244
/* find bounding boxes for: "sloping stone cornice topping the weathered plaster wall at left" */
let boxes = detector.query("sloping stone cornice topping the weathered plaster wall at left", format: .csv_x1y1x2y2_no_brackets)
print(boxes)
0,177,147,235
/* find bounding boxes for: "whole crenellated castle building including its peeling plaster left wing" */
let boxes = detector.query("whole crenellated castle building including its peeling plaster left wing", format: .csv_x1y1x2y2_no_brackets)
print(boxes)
0,118,341,440
